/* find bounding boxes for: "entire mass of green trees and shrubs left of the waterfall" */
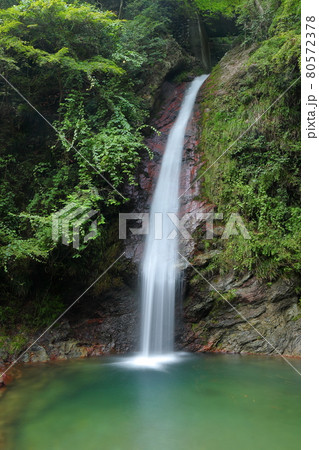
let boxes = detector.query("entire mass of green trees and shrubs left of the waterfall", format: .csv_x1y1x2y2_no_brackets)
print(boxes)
0,0,185,340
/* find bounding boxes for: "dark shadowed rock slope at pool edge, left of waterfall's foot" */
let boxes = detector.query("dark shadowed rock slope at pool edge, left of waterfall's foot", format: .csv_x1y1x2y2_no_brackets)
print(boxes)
18,287,138,363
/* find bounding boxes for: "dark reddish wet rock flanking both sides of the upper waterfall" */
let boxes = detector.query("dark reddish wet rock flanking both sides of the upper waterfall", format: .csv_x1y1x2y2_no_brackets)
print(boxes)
125,80,212,265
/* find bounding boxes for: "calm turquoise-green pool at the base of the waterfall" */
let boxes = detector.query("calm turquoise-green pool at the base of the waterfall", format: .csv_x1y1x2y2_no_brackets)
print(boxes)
0,355,300,450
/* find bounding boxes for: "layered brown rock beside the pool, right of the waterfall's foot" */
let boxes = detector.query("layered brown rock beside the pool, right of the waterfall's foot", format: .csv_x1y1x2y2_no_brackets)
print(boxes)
179,274,301,356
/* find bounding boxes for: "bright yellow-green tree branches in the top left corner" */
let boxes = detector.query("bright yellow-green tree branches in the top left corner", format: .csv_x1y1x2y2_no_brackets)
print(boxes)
0,0,123,77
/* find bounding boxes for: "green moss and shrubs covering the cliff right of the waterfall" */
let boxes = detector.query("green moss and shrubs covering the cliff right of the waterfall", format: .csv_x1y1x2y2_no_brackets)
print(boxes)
201,1,300,280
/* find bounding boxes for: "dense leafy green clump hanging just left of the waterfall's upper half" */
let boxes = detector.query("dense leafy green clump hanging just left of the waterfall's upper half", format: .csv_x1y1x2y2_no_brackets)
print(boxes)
56,90,148,191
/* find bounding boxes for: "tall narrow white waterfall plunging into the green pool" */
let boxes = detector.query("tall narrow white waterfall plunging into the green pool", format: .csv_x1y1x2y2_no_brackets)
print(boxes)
140,75,207,359
